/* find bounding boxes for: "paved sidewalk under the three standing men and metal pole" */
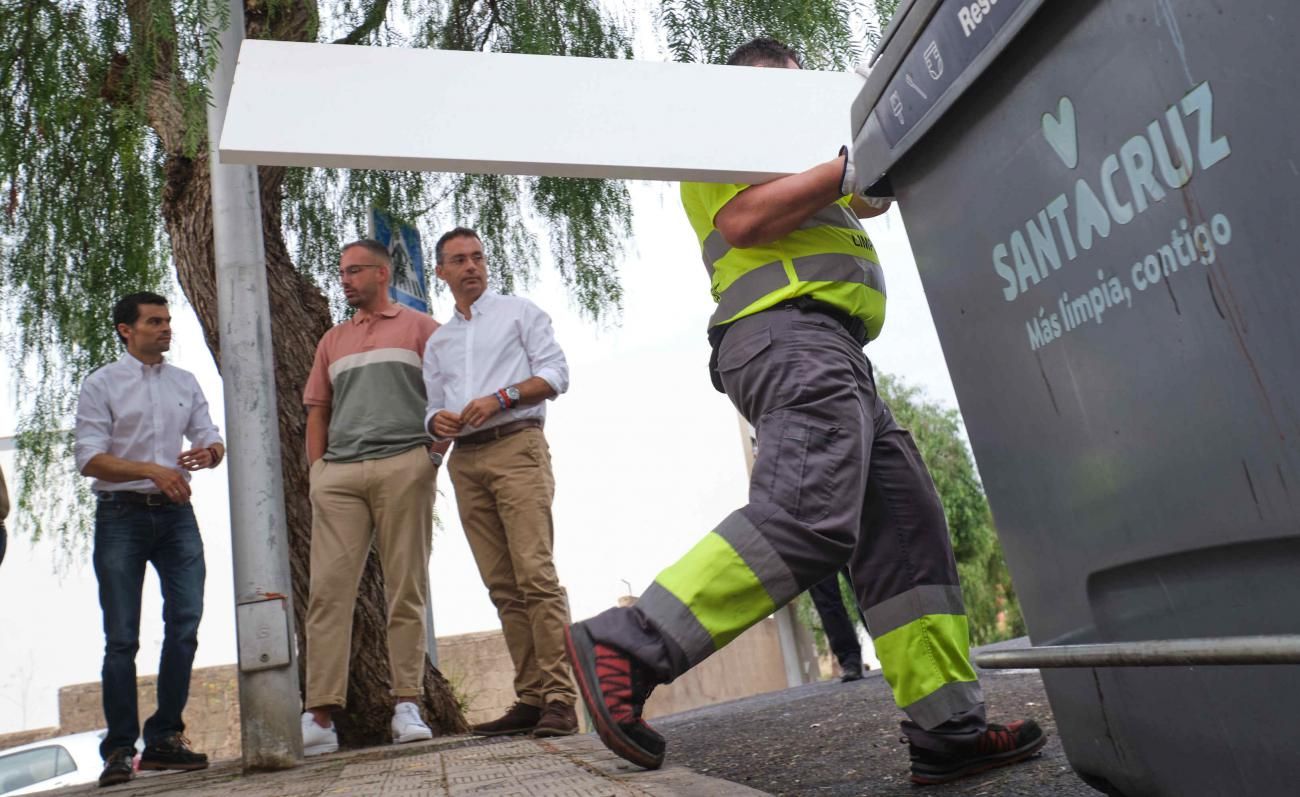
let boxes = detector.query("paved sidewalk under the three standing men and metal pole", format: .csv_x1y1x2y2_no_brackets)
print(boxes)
46,735,763,797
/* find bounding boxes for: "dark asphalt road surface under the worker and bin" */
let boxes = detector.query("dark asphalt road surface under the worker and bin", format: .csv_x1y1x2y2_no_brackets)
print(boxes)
651,671,1099,797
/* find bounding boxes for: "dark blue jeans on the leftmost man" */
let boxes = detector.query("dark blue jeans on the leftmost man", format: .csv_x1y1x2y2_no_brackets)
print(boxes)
95,494,207,758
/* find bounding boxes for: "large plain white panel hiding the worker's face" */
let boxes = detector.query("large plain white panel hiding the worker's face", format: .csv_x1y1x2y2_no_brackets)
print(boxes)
221,40,862,182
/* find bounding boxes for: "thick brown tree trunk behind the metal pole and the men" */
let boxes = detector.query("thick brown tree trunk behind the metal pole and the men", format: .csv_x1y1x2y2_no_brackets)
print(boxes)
151,0,467,746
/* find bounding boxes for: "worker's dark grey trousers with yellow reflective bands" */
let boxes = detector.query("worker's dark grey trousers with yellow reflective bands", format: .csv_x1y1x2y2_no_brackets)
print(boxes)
588,307,985,749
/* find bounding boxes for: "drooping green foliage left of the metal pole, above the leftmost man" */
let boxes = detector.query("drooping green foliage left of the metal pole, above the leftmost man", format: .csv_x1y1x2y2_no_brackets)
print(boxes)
0,0,185,545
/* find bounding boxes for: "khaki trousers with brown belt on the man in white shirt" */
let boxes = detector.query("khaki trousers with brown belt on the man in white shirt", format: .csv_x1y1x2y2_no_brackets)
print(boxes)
449,428,576,707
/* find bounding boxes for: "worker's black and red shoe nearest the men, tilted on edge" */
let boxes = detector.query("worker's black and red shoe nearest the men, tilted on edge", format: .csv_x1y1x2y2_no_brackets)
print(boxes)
564,623,667,770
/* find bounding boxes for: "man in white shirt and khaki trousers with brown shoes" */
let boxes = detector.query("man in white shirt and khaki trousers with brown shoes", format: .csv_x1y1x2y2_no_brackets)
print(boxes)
424,228,577,736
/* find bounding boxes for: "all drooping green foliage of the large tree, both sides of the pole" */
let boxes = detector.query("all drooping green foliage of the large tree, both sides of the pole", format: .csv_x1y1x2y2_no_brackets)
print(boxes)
0,0,875,538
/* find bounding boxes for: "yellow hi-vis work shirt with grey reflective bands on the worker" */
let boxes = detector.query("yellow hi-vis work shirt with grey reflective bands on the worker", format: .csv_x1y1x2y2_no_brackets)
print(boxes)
701,203,885,338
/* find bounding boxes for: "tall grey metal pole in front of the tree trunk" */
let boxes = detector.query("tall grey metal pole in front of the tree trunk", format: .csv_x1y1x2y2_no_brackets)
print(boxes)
208,0,303,770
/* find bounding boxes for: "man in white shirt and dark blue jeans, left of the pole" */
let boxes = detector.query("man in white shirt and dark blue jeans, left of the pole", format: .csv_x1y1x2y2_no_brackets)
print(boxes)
75,293,225,787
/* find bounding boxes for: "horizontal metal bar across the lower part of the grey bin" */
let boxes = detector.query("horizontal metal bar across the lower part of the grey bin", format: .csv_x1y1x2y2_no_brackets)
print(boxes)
975,634,1300,670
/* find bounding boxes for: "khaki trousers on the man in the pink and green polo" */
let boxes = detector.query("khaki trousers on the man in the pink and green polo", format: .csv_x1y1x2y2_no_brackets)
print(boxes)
307,446,437,709
